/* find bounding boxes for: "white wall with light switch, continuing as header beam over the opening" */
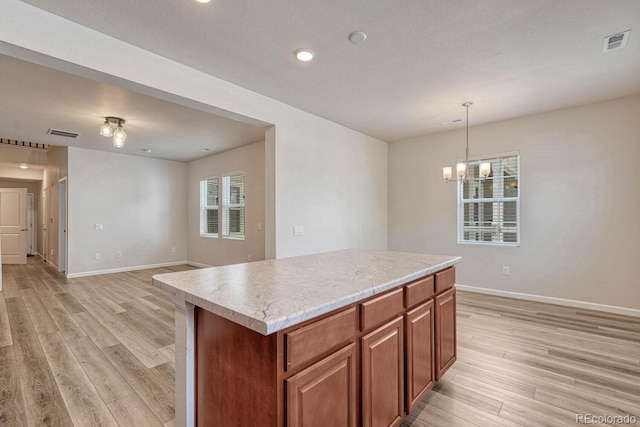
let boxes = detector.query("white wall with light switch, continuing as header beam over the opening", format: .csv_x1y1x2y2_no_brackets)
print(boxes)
0,0,387,257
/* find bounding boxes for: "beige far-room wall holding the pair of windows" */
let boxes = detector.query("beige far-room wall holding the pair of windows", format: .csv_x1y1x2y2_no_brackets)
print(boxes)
187,141,265,265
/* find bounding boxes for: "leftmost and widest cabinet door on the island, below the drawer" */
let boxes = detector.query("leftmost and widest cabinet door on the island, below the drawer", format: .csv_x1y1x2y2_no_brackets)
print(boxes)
285,343,357,427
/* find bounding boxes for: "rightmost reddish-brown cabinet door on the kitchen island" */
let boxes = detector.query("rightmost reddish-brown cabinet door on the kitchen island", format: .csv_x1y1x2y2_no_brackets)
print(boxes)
435,288,457,381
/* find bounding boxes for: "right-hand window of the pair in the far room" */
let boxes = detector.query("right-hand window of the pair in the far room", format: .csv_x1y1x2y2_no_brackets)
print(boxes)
222,173,245,239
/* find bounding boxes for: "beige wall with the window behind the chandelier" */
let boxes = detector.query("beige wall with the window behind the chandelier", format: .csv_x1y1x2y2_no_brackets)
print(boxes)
389,96,640,309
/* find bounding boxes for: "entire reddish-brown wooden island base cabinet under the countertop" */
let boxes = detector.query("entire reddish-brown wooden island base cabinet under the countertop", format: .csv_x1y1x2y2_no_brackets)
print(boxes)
195,268,456,427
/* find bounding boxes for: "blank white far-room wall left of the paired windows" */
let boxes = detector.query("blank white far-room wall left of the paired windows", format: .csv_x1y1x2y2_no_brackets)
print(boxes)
68,147,187,277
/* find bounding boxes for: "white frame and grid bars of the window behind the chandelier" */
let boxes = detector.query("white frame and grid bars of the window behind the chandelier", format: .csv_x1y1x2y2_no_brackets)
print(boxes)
457,151,522,247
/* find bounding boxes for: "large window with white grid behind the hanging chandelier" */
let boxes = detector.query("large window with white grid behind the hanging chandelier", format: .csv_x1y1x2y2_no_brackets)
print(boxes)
458,153,520,246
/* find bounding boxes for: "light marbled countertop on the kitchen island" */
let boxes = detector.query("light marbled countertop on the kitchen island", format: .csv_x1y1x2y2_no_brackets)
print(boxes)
153,249,462,335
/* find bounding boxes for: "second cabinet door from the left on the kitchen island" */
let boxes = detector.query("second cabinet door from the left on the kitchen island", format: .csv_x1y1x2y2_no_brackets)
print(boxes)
361,316,404,427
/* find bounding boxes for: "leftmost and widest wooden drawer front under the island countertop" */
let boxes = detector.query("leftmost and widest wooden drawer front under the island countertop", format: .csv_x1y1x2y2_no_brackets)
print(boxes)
284,307,358,371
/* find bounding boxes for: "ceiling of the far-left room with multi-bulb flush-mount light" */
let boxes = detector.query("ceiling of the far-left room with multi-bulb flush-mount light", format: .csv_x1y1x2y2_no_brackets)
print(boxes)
0,55,264,161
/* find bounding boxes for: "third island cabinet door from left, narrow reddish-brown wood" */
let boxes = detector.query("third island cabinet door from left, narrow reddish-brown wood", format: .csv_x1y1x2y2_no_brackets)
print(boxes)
406,300,435,413
